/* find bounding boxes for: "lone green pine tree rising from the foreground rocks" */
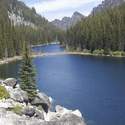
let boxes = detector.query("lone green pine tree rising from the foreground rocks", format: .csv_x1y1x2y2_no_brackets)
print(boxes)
19,42,37,101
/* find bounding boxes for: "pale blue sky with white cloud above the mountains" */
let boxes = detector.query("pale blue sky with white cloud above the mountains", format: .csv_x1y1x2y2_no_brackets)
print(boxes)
20,0,102,21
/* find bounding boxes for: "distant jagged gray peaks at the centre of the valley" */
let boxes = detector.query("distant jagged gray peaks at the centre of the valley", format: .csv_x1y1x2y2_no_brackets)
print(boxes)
51,12,84,30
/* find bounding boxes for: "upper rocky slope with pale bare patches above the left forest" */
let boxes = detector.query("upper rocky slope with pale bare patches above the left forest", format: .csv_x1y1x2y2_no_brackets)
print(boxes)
5,0,48,27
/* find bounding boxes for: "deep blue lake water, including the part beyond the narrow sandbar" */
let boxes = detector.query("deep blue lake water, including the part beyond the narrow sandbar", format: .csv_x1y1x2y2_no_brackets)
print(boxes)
0,45,125,125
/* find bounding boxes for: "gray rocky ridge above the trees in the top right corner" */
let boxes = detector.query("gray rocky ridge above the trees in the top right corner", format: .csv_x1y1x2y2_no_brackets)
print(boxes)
92,0,125,14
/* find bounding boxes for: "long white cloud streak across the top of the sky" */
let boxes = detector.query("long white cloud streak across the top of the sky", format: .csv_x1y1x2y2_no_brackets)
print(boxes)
33,0,101,13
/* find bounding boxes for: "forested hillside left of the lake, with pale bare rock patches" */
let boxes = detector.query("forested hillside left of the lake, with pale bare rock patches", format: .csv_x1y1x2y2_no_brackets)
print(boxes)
0,0,63,58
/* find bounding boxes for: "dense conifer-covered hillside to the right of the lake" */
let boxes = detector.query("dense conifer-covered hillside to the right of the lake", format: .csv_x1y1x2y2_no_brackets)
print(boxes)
66,4,125,54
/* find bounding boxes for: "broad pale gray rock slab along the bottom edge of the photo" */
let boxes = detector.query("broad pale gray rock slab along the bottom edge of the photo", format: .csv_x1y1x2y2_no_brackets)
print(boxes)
0,113,86,125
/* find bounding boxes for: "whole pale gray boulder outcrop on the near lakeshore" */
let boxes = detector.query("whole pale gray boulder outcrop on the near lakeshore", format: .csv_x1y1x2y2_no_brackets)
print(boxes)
0,78,85,125
